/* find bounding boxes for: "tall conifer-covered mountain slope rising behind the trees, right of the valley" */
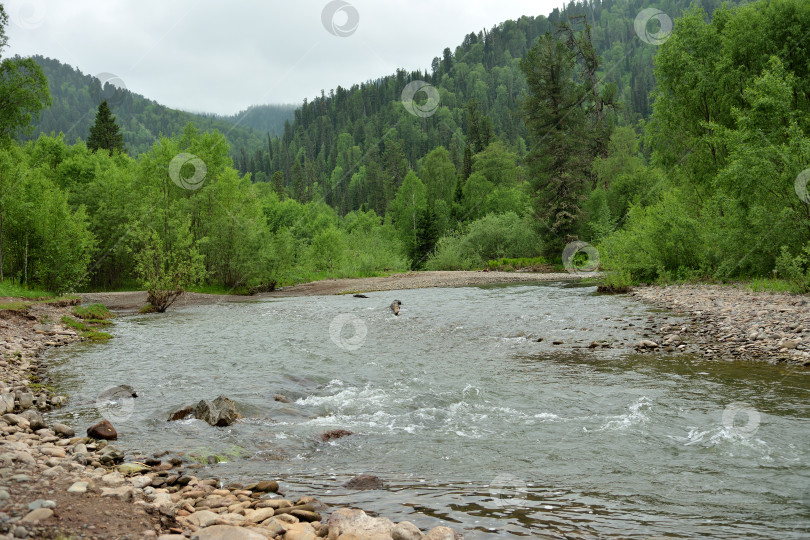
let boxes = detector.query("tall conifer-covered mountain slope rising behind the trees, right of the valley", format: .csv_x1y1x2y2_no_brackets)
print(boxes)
246,0,737,214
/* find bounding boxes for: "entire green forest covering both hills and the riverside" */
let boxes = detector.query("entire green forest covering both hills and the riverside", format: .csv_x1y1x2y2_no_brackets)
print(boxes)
0,0,810,307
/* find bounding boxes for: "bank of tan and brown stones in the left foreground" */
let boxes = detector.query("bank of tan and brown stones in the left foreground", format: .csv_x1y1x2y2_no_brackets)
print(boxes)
0,302,460,540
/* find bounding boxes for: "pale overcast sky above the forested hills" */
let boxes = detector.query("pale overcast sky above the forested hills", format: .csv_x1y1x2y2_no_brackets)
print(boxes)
0,0,564,114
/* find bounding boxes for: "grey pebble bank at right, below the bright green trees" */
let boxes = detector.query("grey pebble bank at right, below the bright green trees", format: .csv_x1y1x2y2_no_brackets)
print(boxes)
632,285,810,366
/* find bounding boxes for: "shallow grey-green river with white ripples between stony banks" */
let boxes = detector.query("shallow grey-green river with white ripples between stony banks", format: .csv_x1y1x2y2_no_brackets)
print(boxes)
46,283,810,539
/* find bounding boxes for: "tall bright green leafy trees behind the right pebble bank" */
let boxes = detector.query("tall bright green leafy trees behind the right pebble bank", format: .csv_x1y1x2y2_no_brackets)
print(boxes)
586,0,810,291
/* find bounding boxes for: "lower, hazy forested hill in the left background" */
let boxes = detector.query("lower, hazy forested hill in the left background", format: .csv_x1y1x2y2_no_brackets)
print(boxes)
21,56,294,156
